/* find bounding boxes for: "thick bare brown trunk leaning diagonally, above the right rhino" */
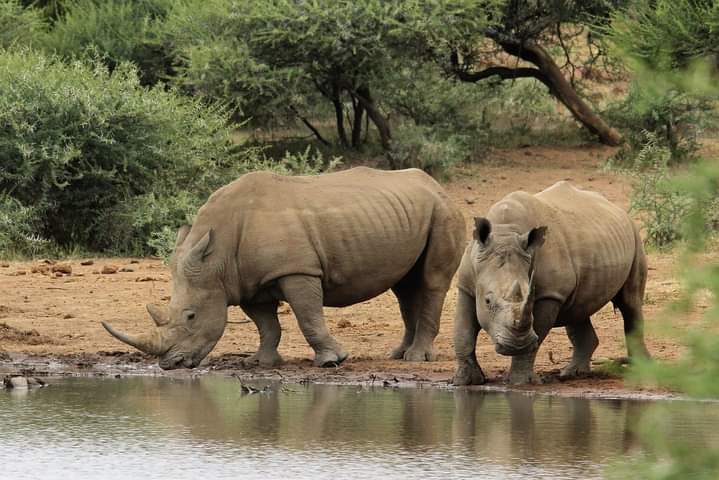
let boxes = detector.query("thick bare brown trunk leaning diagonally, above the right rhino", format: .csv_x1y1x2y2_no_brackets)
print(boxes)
493,37,622,146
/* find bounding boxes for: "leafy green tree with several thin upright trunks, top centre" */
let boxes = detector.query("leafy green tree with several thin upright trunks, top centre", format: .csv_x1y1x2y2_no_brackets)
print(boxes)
238,0,414,149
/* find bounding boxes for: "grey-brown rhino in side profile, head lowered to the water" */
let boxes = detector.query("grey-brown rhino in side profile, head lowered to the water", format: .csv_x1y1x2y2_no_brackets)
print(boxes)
103,167,465,369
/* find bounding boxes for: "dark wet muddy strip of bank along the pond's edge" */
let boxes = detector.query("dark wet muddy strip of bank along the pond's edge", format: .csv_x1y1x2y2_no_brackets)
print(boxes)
0,351,681,400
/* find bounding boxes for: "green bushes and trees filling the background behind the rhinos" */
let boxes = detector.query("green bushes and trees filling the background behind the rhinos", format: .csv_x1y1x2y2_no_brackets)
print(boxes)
0,0,719,255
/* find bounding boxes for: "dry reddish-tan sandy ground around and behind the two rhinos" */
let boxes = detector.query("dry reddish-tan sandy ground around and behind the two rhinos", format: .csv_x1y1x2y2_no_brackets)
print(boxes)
0,146,708,394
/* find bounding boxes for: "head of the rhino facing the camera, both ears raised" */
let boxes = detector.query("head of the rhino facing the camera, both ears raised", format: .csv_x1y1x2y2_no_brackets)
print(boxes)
472,218,547,355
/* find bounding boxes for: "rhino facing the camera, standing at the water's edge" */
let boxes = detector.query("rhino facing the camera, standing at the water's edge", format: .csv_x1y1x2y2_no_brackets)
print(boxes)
454,182,648,385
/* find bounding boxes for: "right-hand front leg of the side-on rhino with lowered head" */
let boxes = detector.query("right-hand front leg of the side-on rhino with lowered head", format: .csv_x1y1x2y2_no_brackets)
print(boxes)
278,275,347,367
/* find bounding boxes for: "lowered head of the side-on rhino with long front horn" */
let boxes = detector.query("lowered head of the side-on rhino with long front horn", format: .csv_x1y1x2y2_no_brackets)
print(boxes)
102,225,227,370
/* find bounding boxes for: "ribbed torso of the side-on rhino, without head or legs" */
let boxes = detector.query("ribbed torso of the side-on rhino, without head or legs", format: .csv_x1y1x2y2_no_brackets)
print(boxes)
200,168,453,306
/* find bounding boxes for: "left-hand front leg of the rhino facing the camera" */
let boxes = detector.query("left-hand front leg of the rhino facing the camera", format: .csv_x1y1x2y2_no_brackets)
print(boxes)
452,290,486,385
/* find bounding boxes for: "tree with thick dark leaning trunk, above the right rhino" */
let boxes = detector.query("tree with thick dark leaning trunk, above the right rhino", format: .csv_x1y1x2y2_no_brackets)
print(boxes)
405,0,632,145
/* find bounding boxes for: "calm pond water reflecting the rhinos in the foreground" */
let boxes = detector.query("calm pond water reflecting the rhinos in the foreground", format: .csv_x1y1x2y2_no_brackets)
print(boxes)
0,376,719,480
